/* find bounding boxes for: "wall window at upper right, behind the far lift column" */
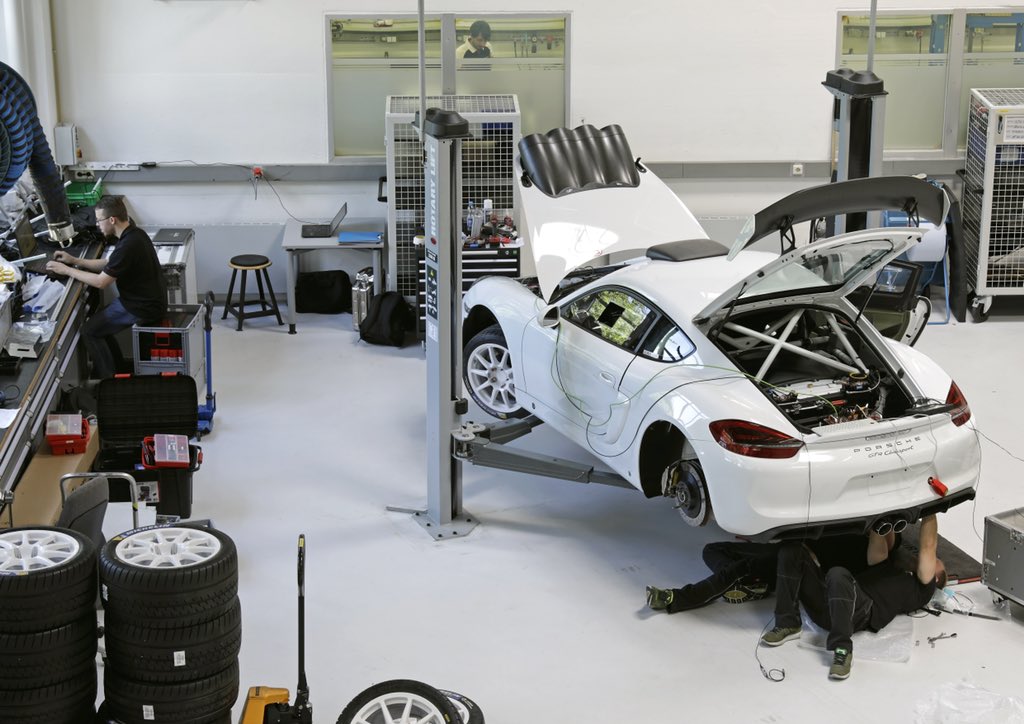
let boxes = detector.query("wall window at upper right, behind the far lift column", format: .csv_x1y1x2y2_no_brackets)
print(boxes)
836,7,1024,159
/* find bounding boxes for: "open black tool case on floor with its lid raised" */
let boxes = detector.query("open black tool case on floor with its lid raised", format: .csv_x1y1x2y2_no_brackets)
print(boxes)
95,374,202,518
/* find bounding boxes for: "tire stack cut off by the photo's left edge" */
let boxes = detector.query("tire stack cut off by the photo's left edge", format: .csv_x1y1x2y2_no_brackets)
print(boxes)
0,526,96,724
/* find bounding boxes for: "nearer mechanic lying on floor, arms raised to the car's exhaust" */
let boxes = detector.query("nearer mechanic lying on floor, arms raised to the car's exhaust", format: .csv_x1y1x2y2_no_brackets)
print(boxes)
761,515,946,679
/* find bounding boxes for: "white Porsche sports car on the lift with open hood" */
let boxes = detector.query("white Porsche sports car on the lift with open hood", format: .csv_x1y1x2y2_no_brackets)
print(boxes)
463,126,981,541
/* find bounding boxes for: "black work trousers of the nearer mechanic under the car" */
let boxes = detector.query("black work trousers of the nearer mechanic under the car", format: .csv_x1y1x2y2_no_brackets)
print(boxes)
775,543,871,651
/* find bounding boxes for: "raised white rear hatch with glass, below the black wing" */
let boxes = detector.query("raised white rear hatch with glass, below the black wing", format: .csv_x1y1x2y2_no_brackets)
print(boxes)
694,228,928,321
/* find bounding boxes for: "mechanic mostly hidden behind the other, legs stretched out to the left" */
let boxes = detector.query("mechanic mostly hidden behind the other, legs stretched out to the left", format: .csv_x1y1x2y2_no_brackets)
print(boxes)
647,533,902,613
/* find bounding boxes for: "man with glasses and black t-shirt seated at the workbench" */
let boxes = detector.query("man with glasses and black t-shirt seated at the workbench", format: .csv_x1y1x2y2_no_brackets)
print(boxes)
46,196,167,379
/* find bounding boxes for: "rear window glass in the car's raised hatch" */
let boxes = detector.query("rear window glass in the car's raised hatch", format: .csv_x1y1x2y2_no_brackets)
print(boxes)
739,239,894,299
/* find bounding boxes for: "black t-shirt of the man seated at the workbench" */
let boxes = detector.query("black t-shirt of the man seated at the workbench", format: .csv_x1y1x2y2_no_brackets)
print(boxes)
103,224,167,323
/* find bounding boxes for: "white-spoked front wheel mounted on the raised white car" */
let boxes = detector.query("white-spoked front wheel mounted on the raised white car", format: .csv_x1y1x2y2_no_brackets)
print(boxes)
462,325,529,420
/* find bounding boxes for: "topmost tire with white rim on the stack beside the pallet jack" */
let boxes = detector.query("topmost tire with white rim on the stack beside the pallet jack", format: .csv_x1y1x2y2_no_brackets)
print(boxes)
99,523,239,629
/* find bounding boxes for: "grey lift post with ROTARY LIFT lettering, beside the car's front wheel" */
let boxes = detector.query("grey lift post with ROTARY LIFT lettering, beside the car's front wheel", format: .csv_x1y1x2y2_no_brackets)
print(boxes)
417,108,476,540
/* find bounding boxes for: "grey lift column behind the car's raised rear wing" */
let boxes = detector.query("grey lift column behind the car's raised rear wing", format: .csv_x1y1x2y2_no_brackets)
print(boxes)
822,68,888,235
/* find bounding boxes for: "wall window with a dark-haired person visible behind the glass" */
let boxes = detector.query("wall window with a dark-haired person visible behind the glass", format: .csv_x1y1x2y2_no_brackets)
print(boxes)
327,13,568,158
